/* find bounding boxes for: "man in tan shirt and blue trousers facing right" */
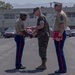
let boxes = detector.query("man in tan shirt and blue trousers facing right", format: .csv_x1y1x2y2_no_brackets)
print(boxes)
15,12,32,69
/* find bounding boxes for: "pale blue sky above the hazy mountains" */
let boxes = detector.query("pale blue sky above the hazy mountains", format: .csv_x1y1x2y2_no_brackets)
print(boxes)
0,0,75,5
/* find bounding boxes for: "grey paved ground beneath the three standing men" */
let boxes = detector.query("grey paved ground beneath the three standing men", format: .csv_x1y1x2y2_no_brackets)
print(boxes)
0,37,75,75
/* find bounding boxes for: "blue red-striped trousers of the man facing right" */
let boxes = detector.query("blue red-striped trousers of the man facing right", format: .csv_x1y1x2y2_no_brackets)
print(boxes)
15,35,25,65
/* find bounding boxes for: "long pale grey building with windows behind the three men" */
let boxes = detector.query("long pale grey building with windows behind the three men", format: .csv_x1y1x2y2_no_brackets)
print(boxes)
0,5,75,29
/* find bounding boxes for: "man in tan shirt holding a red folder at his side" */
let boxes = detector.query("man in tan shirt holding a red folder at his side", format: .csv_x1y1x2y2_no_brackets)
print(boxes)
53,2,67,73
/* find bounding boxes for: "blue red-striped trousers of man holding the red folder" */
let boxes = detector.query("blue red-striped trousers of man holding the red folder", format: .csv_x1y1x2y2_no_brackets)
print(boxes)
54,31,67,71
